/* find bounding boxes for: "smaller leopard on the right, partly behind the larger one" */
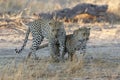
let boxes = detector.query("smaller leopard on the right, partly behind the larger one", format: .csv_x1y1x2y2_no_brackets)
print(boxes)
39,27,91,61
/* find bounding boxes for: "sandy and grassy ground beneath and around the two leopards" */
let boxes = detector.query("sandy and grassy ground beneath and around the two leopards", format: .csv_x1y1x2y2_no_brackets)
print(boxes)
0,25,120,80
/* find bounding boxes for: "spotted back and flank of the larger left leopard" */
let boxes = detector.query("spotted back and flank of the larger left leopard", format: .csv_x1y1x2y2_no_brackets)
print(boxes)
28,19,50,37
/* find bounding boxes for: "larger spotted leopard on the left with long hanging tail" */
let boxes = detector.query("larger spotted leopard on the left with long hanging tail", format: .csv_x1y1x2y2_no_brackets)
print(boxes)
15,19,66,61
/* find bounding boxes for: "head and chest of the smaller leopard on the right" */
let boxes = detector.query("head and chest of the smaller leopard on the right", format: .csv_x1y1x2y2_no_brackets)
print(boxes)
73,27,90,52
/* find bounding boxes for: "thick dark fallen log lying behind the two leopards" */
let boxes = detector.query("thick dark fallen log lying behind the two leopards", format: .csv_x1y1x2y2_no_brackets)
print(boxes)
39,3,108,20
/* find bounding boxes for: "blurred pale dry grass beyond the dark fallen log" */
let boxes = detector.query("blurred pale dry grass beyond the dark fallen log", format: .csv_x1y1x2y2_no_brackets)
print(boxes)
0,0,120,16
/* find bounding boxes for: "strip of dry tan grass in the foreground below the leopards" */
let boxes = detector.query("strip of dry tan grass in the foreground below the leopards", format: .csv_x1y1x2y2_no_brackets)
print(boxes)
0,55,120,80
